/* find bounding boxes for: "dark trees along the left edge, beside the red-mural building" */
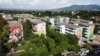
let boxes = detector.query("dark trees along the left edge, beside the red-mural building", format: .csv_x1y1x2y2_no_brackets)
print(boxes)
0,15,9,56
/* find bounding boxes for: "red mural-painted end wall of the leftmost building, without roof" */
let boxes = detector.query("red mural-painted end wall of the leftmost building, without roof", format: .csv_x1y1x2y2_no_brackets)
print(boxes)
9,25,23,43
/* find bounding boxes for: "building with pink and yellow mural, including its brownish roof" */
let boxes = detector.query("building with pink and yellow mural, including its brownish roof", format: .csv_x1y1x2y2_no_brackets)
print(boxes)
30,19,46,35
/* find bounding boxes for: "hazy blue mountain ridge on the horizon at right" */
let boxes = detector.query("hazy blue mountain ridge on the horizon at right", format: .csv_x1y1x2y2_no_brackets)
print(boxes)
53,5,100,11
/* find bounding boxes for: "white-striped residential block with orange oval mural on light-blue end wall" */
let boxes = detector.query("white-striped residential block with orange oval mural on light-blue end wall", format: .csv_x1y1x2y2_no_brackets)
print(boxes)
56,23,83,39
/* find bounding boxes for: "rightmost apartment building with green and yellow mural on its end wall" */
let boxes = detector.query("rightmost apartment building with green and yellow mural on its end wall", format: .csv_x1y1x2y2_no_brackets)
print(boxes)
69,19,95,39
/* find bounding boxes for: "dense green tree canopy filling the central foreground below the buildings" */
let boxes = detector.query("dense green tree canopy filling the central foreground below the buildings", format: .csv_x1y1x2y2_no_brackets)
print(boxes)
11,21,80,56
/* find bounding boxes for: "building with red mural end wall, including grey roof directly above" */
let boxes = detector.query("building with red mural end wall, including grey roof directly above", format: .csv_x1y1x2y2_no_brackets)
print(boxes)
7,21,23,43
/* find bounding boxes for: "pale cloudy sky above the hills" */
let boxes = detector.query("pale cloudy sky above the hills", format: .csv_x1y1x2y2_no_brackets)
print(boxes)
0,0,100,10
